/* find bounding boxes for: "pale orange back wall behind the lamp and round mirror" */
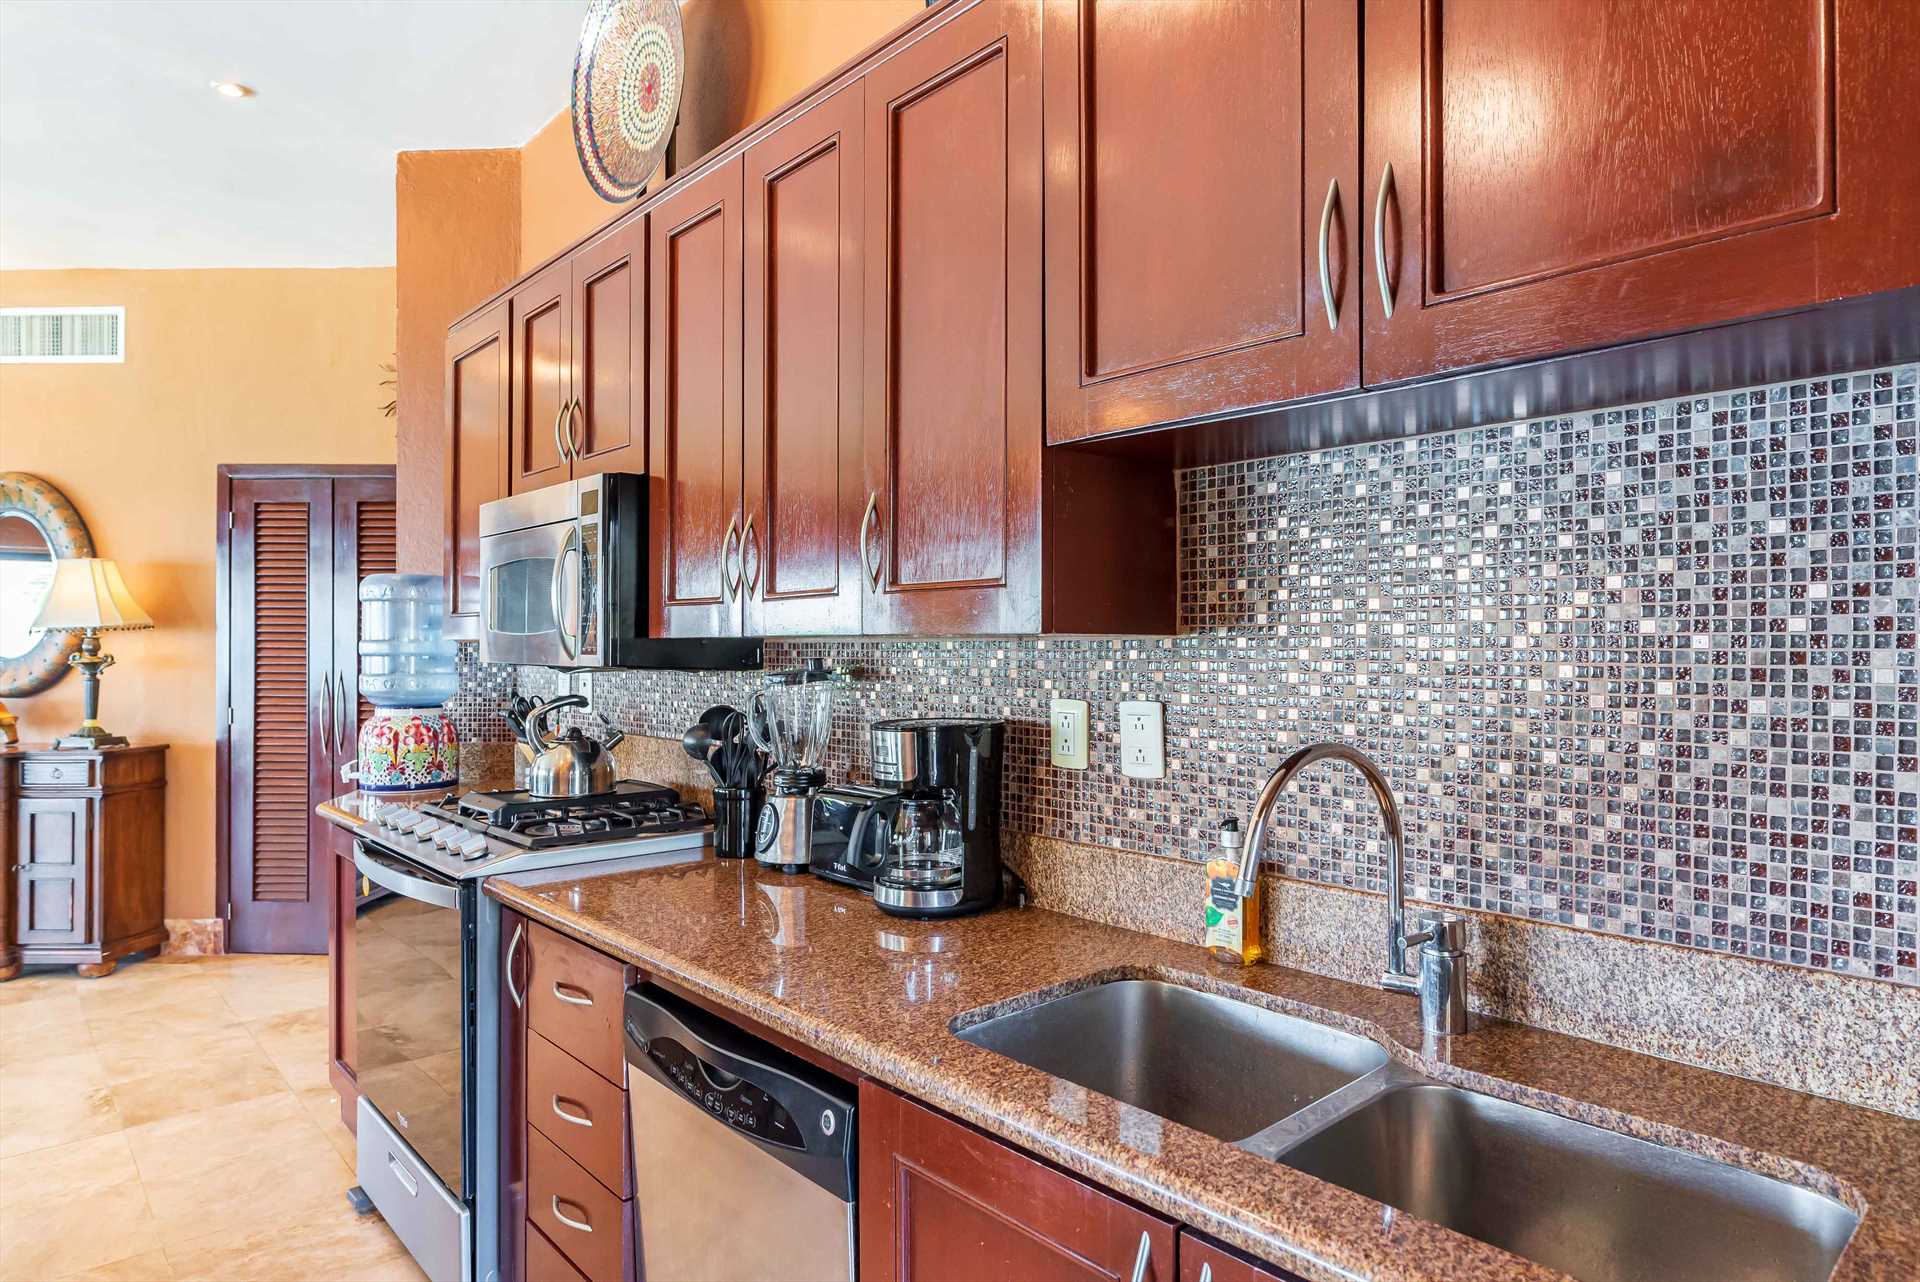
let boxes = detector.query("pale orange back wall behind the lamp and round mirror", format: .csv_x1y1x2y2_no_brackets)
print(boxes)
0,267,394,917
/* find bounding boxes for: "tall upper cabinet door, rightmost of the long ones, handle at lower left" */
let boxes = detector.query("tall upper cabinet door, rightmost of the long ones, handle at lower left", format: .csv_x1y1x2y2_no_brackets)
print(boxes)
862,2,1044,635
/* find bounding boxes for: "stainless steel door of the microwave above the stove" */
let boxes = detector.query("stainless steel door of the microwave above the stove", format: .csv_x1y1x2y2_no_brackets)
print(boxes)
480,520,599,668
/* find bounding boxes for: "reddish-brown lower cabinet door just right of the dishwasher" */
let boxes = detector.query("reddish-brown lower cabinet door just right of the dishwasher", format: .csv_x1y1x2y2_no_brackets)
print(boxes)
860,1082,1175,1282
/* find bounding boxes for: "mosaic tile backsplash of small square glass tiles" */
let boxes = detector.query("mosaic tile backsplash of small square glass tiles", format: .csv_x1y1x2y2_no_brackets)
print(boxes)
487,365,1920,985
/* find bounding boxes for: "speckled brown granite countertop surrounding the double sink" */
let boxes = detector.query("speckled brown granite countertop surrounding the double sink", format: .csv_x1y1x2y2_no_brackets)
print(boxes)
488,856,1920,1282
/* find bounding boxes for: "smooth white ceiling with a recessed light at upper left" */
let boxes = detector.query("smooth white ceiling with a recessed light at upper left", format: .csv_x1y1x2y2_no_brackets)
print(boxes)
0,0,586,267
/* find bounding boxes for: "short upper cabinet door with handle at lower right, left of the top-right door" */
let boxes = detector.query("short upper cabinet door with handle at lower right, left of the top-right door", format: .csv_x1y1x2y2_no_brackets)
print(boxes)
1044,0,1361,441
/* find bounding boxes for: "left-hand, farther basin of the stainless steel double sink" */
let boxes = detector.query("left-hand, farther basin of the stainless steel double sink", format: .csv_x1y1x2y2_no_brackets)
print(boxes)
956,979,1386,1140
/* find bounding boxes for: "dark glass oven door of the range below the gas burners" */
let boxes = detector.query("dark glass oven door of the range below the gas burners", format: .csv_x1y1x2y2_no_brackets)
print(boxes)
353,843,472,1201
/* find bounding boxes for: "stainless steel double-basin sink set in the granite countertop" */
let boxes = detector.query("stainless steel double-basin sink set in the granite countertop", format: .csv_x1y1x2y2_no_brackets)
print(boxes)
954,979,1859,1282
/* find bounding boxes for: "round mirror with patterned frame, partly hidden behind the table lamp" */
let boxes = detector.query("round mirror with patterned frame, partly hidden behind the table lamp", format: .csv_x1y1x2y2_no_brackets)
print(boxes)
0,472,94,699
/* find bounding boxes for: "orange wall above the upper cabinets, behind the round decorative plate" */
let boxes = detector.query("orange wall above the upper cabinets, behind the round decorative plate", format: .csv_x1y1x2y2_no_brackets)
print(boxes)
520,0,925,271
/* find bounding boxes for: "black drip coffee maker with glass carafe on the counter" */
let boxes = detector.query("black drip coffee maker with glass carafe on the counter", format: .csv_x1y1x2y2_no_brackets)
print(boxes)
870,718,1006,917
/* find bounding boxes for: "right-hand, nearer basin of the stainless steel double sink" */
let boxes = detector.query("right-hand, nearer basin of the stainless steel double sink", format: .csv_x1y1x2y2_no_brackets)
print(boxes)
1279,1084,1859,1282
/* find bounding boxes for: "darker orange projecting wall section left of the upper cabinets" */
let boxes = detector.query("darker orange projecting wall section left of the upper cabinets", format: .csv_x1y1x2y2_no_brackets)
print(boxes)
394,148,520,574
